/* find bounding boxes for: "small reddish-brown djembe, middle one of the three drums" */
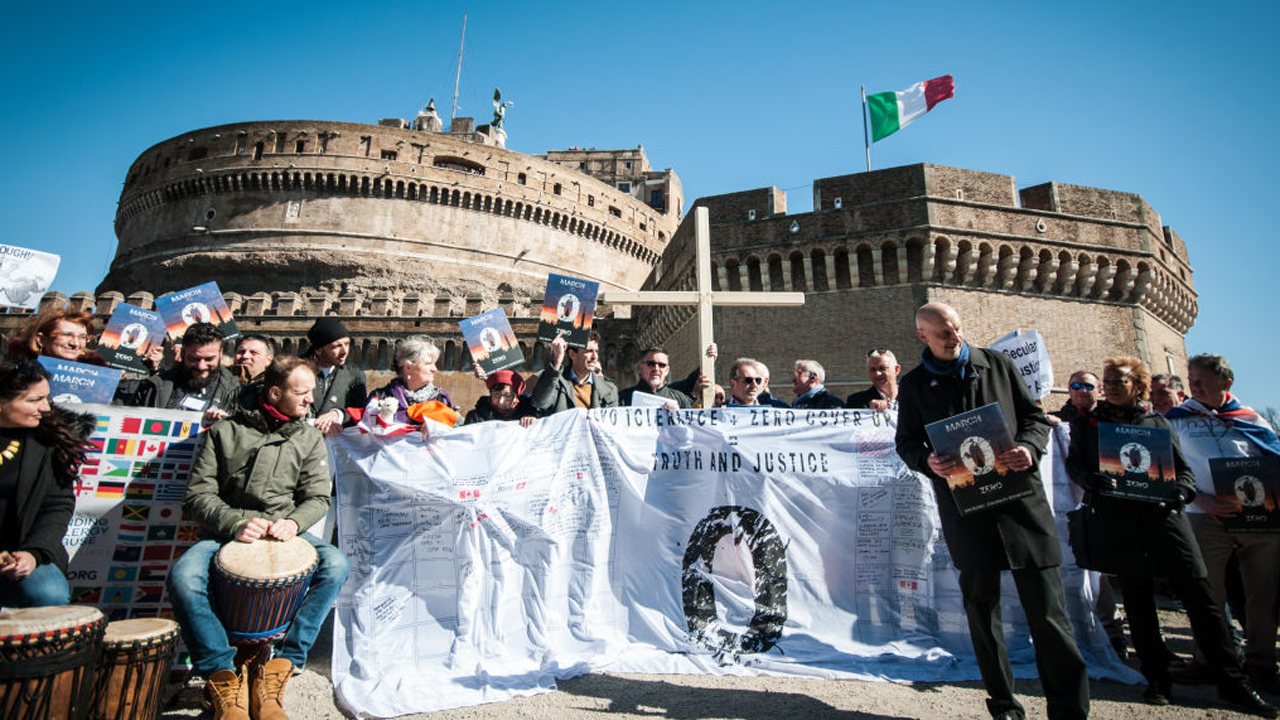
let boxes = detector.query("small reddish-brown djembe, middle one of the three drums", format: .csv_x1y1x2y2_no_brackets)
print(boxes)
90,618,178,720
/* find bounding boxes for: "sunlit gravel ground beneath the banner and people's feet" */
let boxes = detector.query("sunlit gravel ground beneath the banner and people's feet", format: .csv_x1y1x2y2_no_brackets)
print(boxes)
160,610,1280,720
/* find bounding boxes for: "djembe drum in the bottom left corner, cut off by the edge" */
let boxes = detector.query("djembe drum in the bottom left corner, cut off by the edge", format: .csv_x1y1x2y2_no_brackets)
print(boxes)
0,605,106,720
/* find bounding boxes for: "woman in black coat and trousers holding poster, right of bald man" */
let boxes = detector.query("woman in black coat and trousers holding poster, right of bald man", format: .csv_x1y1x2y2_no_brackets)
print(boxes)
1066,357,1275,717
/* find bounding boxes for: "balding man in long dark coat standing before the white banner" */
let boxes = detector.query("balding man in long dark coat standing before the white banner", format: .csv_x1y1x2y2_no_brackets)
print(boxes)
896,302,1089,720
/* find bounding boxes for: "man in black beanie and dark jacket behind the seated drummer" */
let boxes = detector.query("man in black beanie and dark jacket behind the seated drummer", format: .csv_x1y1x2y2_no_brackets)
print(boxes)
307,318,369,437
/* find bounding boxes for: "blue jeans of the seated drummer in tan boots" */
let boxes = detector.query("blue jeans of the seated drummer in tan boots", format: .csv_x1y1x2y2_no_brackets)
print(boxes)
168,533,351,676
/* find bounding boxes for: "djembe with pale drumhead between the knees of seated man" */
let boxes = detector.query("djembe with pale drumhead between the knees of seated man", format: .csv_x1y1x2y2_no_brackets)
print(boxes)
209,537,319,644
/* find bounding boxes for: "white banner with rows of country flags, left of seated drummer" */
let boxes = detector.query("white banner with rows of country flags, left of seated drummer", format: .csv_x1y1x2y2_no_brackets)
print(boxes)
63,405,201,638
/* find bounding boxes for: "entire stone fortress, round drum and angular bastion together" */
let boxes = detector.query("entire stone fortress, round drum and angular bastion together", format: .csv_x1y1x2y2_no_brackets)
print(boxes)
0,108,1197,410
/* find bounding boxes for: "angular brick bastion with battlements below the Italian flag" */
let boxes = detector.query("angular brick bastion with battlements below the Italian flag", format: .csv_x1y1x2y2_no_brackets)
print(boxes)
636,164,1197,397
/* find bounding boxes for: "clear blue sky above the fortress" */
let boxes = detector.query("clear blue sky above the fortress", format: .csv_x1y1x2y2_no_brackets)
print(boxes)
0,0,1280,407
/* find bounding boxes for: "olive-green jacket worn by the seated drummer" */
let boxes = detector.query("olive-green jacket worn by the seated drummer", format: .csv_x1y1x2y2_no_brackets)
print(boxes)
182,410,330,541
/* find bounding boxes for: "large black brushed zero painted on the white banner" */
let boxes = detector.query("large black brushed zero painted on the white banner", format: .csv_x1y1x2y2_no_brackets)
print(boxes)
681,505,787,652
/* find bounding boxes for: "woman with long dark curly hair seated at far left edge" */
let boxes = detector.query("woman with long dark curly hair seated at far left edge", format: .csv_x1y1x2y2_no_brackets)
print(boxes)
0,363,93,607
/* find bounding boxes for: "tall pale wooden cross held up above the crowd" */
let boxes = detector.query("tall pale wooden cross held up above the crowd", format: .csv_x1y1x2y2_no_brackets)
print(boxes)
600,208,804,407
